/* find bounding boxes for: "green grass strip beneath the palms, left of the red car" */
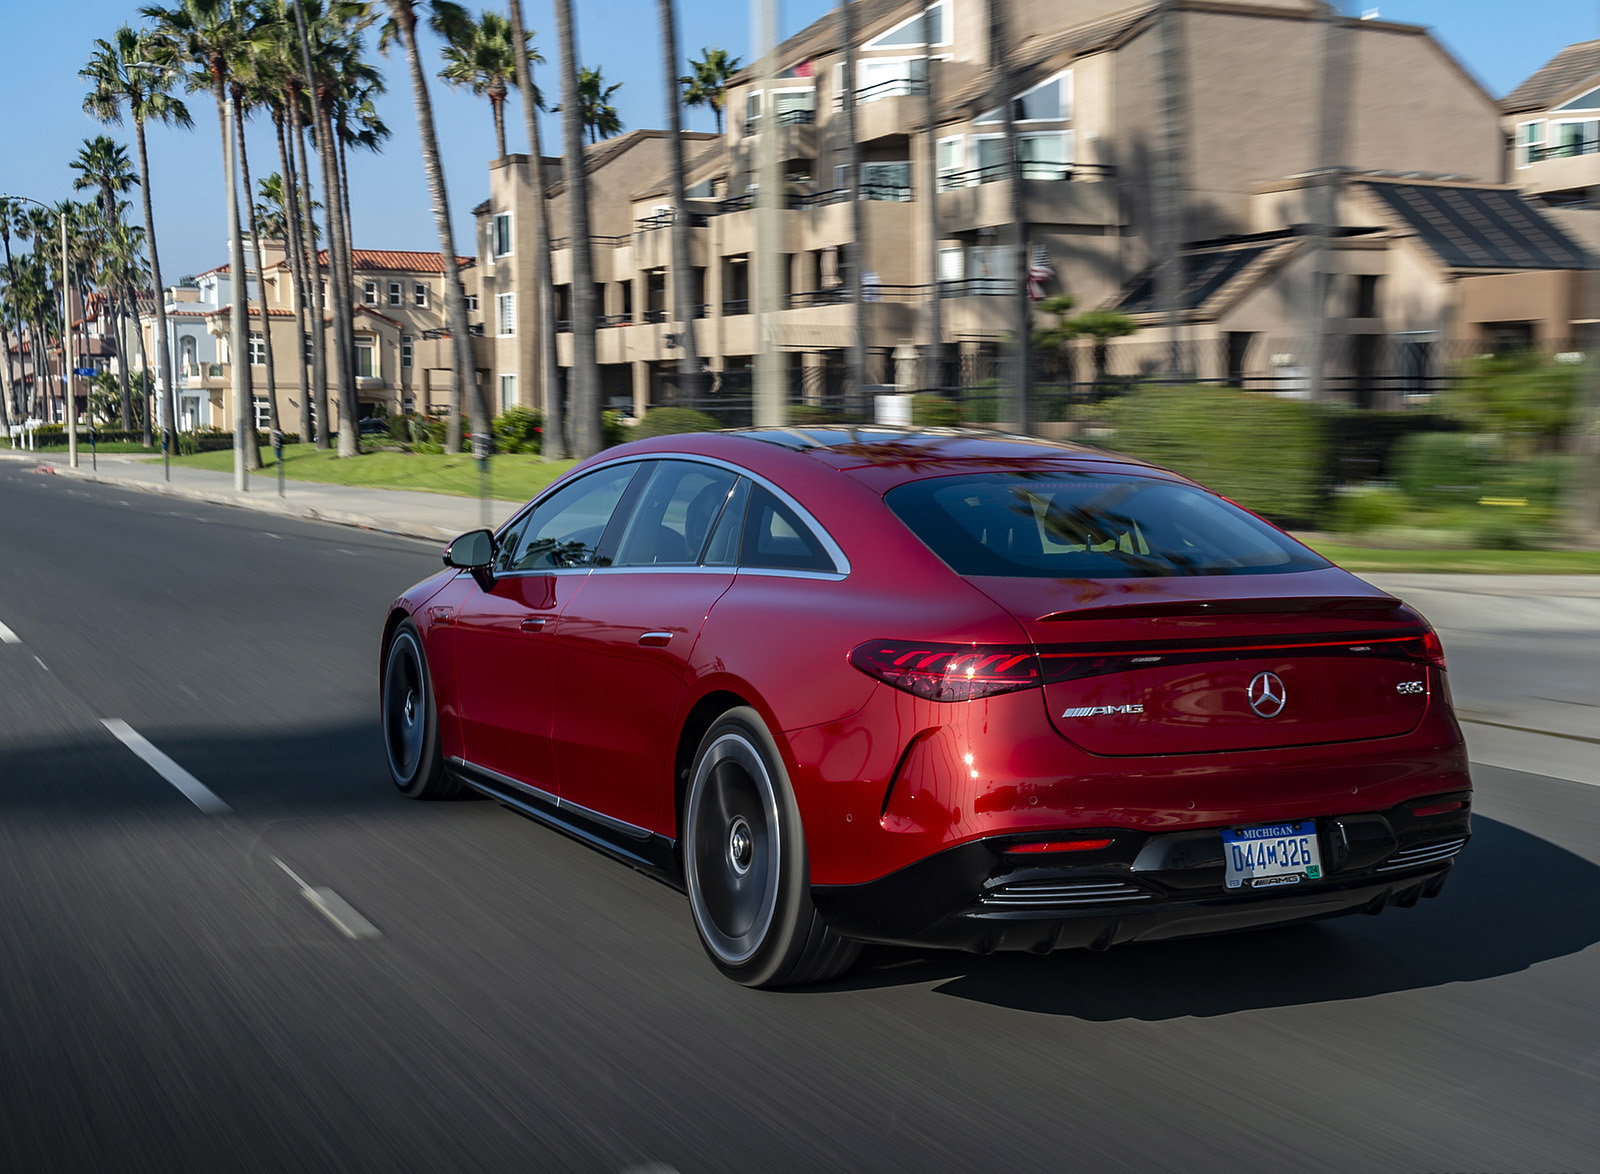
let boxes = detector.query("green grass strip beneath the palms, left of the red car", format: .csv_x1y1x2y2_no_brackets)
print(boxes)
160,445,576,501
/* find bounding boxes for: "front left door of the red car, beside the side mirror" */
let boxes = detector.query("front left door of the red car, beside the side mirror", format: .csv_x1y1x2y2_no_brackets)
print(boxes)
456,462,640,798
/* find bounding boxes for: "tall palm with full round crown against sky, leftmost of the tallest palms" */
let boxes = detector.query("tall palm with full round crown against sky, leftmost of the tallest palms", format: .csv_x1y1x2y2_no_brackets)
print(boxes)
78,24,194,454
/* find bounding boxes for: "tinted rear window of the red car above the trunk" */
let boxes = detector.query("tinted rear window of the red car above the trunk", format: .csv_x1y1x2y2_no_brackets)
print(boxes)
885,472,1328,579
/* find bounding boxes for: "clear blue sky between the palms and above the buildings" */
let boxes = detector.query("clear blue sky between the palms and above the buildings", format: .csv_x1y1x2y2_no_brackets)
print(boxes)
0,0,1600,283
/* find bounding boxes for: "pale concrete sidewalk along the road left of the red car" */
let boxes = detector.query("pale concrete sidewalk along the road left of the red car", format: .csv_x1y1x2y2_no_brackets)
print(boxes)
0,449,518,542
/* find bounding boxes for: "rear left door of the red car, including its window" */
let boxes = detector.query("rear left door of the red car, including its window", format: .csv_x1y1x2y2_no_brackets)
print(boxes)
554,459,742,835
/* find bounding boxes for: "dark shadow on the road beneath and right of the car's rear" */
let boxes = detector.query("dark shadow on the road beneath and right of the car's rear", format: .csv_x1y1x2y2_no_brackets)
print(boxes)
818,816,1600,1020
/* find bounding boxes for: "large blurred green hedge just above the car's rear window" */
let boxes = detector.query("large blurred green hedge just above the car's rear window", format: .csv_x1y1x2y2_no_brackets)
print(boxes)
1107,387,1322,525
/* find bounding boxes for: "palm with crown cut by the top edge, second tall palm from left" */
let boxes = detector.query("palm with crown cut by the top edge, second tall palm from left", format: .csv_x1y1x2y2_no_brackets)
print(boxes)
139,0,261,470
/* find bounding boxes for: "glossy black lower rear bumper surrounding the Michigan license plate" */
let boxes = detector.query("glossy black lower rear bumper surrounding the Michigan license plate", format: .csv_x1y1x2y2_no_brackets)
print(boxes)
811,793,1470,953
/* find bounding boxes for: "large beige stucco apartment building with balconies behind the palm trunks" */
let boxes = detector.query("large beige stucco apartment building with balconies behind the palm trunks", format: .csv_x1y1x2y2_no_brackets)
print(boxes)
477,0,1587,411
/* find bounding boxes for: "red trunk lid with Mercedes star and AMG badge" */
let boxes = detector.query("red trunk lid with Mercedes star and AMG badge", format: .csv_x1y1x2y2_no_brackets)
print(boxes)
971,568,1432,755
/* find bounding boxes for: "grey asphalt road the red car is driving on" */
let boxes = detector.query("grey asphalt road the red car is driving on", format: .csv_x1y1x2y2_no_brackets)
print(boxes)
0,465,1600,1174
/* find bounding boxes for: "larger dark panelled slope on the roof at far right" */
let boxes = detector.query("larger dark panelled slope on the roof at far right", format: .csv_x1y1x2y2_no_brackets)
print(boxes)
1362,179,1594,269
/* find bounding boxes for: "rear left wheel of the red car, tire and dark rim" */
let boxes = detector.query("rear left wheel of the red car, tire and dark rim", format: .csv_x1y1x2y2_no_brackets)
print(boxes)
683,707,861,987
